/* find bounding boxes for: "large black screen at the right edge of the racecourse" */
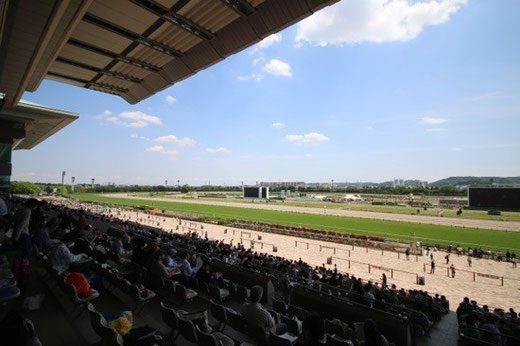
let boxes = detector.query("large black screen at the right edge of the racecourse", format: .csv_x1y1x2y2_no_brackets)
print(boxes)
468,187,520,209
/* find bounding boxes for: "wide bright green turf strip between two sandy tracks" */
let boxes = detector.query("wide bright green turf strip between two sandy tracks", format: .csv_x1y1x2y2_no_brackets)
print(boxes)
71,194,520,252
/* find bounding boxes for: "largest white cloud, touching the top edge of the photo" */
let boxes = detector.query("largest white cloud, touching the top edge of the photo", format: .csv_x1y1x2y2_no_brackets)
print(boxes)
295,0,467,46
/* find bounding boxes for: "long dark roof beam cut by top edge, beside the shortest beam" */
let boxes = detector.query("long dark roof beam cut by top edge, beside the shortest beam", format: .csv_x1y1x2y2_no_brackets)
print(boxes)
129,0,215,40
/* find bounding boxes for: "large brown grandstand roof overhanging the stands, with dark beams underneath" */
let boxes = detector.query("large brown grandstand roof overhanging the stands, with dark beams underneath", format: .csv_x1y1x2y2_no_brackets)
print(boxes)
0,0,338,106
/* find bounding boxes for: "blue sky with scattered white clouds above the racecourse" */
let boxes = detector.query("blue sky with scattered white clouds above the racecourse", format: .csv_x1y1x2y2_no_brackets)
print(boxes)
12,0,520,185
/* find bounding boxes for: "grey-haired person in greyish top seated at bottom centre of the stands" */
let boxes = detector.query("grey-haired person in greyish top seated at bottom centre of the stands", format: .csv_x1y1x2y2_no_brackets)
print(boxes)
242,285,287,335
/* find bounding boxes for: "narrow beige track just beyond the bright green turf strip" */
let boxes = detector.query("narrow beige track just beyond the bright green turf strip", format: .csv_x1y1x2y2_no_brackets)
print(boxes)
103,193,520,232
